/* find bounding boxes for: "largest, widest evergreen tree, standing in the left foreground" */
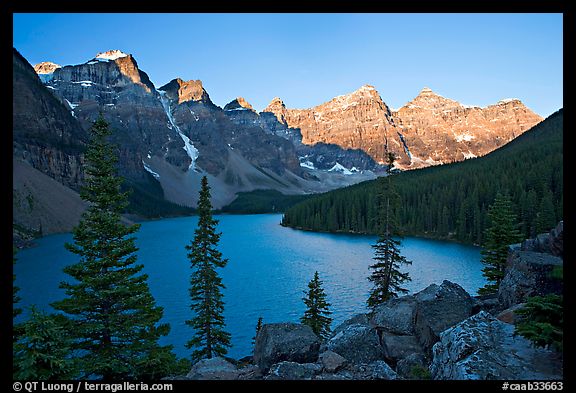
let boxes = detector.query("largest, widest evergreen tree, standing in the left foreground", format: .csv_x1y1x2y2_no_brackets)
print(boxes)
53,115,175,380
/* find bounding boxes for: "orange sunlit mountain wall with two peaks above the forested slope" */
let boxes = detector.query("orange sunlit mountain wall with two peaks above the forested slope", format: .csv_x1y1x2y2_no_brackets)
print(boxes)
264,85,542,169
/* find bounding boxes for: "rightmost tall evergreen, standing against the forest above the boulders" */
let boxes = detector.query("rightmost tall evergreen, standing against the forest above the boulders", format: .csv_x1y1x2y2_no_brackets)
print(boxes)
478,193,522,295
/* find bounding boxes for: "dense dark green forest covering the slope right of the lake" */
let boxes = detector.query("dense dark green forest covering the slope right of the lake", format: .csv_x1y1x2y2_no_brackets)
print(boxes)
282,109,564,244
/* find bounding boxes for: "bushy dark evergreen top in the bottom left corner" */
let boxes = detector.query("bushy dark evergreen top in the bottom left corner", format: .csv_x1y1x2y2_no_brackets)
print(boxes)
13,307,76,381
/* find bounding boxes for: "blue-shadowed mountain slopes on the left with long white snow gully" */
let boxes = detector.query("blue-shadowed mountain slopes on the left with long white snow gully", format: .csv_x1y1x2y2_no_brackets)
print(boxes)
13,46,376,234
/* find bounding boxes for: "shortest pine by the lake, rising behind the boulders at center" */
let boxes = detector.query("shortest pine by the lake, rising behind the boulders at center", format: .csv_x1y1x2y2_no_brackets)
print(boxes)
300,272,332,339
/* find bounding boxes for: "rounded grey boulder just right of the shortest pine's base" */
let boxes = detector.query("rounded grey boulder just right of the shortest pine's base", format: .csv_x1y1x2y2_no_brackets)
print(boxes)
326,324,384,364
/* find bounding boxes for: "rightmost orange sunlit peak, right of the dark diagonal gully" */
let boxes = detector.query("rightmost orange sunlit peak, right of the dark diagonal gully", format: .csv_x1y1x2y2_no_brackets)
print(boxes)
393,88,543,168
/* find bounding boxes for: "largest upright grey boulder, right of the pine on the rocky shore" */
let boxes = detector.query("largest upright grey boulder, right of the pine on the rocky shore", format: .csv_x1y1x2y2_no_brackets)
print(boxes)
414,280,475,352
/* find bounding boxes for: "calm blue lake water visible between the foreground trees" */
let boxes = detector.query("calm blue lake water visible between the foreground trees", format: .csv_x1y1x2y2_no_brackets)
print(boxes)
14,214,486,359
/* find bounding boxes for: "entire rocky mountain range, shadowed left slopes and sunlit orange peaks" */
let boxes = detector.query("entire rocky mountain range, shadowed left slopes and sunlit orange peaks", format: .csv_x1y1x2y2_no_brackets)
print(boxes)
13,45,541,236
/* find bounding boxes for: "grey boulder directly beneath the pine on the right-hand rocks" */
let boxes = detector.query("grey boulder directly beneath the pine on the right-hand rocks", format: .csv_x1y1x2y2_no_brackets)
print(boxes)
370,295,416,335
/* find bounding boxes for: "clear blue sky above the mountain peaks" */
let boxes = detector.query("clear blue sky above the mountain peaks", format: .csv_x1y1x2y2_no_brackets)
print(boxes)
13,13,563,117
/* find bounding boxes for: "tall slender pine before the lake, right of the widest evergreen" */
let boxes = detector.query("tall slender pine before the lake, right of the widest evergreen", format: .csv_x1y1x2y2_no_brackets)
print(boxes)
186,176,230,362
